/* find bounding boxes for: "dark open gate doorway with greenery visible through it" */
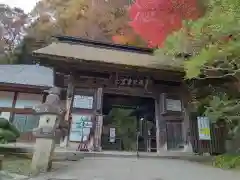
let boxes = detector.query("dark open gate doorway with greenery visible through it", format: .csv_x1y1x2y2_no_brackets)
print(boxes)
101,94,156,152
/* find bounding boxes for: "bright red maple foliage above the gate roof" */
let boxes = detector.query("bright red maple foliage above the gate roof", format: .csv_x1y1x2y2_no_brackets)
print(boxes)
129,0,201,47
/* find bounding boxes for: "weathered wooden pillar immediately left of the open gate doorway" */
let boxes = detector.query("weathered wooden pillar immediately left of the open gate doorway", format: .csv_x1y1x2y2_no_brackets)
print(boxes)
94,88,103,151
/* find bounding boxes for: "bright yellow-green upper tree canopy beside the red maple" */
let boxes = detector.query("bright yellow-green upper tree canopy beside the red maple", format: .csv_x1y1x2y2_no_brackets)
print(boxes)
159,0,240,80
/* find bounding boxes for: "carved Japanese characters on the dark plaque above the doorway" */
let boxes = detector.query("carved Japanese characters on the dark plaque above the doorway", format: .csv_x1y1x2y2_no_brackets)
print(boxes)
115,76,148,88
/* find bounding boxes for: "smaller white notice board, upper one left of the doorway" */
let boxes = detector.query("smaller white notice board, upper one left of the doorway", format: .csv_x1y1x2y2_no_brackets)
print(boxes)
73,95,93,109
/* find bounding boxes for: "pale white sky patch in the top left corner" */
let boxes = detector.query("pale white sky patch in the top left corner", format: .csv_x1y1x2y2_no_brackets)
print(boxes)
0,0,39,13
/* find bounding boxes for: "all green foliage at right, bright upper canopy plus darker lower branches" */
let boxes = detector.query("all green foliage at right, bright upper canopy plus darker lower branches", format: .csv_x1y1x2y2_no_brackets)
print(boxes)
157,0,240,142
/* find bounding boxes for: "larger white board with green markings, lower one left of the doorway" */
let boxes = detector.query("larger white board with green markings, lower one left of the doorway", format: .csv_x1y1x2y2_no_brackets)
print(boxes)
69,114,92,142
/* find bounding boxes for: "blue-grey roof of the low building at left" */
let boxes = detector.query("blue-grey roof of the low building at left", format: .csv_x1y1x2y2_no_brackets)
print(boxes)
0,65,54,87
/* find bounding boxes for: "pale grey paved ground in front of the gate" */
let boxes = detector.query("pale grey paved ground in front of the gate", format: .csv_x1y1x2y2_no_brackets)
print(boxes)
30,157,240,180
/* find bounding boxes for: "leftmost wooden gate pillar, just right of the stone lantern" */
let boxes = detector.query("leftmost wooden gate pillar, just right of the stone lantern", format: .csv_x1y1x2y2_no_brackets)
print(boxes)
61,75,74,147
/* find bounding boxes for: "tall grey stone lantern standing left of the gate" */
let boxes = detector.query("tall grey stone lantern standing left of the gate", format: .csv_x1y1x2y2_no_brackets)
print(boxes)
31,88,64,174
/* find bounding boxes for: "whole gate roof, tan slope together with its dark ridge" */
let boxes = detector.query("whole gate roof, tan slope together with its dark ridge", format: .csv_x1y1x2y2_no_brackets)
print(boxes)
33,36,182,71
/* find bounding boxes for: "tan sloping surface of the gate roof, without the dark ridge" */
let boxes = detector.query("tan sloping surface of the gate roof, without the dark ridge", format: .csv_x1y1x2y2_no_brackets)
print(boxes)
33,42,181,71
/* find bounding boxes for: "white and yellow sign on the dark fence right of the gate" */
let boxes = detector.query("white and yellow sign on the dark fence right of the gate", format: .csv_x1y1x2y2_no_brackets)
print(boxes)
197,117,211,140
